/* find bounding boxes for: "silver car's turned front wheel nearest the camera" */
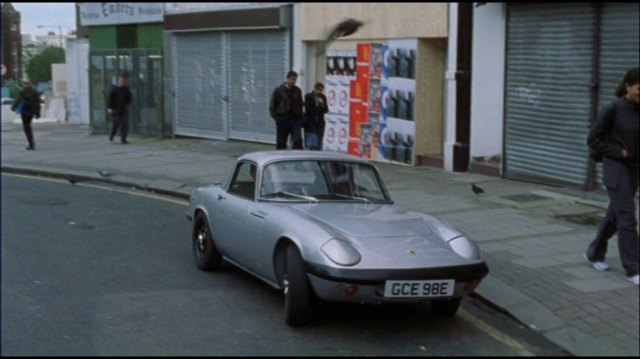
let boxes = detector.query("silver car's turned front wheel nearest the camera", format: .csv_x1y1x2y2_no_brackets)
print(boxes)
284,245,314,327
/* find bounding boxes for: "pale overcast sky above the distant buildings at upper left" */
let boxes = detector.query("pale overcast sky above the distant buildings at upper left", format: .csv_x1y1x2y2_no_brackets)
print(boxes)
11,2,76,38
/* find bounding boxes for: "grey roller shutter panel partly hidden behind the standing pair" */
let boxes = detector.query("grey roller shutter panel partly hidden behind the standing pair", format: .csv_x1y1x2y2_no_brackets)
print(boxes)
228,30,290,143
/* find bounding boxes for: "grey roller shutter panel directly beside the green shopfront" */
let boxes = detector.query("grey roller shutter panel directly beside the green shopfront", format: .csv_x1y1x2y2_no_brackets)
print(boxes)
172,32,227,139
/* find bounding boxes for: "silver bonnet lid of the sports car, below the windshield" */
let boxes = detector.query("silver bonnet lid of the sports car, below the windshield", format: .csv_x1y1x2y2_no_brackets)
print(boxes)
290,203,433,238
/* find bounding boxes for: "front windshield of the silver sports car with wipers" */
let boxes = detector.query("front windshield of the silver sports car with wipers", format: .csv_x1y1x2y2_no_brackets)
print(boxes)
260,160,391,202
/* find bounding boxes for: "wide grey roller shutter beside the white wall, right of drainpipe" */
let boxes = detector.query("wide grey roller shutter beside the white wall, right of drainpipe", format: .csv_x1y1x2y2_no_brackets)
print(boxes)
505,3,593,186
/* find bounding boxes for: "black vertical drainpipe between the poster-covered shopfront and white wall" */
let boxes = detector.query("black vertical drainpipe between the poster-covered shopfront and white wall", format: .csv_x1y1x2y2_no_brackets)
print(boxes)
453,3,473,172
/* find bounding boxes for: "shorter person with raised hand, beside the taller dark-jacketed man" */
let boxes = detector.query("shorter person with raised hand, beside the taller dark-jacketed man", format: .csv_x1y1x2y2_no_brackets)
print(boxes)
302,82,329,150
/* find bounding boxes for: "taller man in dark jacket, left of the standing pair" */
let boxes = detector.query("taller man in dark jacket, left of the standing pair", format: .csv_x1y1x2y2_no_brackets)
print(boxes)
269,71,304,150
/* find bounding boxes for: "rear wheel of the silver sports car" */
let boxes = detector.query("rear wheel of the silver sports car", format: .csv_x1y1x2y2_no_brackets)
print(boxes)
191,212,222,271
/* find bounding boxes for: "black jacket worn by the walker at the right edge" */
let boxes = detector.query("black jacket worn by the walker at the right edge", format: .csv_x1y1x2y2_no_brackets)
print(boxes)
587,96,638,168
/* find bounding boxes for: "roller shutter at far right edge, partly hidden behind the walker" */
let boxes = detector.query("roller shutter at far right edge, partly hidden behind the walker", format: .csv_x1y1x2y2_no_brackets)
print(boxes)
596,3,640,184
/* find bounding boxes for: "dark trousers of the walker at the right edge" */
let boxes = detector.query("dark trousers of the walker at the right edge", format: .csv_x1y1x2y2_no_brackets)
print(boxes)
587,158,639,277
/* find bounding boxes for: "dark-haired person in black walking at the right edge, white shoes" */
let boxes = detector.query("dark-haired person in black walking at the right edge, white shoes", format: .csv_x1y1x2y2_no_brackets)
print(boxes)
584,67,640,285
